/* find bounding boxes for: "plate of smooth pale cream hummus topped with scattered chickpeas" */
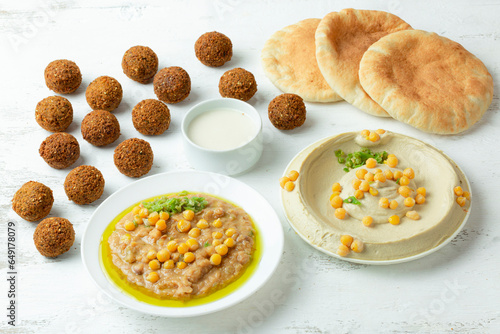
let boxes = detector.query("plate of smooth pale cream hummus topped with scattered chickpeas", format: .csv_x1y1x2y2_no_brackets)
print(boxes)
280,129,471,264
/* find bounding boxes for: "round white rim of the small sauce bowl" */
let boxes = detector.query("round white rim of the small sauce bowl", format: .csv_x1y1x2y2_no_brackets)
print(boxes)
181,97,262,153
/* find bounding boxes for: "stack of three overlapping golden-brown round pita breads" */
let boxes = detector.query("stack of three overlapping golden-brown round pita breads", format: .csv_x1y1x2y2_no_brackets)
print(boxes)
261,9,493,134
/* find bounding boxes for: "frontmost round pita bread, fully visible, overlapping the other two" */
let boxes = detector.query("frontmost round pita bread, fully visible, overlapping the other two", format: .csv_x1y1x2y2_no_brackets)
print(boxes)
359,30,493,134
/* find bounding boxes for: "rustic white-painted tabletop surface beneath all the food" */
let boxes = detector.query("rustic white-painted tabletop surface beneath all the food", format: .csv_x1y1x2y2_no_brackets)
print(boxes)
0,0,500,333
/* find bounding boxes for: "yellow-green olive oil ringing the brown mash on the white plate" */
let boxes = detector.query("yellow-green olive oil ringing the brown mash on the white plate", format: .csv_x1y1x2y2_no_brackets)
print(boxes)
99,193,262,307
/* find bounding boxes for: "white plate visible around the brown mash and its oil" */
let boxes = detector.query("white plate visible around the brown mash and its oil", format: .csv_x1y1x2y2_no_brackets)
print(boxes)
82,171,284,317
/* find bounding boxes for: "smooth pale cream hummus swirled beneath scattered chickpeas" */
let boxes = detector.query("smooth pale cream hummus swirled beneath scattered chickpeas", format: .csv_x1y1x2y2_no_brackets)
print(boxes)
282,131,470,262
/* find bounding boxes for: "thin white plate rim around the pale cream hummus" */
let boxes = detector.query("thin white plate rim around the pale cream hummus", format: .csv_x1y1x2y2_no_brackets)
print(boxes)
280,131,473,266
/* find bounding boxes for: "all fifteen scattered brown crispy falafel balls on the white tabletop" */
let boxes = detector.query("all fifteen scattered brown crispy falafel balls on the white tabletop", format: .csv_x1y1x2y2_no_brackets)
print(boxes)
12,31,306,257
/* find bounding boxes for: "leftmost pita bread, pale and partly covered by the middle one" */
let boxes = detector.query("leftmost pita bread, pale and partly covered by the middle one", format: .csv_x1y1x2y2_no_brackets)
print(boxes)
261,19,342,102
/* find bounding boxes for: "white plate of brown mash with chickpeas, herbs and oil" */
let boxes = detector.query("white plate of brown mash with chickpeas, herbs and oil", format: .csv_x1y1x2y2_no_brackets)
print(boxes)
82,171,284,317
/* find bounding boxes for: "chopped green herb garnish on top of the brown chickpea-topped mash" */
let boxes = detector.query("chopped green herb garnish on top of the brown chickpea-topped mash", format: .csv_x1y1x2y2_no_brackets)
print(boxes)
142,191,208,214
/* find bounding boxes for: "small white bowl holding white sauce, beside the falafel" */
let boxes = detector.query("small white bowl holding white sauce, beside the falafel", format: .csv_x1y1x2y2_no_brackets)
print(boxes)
182,98,263,175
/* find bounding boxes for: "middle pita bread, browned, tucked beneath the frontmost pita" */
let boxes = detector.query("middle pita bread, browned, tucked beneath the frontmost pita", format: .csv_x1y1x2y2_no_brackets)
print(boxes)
316,8,411,117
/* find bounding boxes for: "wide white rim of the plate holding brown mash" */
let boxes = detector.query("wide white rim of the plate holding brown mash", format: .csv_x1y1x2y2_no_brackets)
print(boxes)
80,170,284,318
